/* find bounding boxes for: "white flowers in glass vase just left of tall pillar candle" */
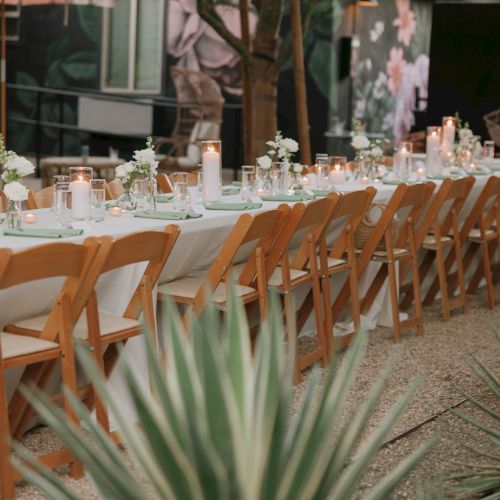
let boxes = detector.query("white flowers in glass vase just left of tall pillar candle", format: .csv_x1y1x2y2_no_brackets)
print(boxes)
115,137,158,212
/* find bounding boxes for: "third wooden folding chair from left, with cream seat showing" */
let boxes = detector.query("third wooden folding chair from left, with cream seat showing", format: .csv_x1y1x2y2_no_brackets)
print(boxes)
158,205,289,322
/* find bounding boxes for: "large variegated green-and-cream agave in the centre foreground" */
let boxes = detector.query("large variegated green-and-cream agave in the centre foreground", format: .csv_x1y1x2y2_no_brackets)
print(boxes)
13,291,434,500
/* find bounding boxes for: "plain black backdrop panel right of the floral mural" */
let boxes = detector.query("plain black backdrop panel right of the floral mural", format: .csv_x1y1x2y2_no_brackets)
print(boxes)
428,3,500,138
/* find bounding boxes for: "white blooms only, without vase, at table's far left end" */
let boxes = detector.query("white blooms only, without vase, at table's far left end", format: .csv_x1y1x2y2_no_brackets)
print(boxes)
0,134,35,201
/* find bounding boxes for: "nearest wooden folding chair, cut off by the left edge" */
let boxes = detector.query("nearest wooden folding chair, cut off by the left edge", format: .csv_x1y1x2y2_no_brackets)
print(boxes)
0,238,99,498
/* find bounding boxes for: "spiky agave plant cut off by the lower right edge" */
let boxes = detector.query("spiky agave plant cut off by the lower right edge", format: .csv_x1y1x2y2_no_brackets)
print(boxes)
449,329,500,499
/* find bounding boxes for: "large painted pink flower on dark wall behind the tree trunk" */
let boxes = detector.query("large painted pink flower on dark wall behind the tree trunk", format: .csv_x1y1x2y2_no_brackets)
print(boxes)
167,0,257,95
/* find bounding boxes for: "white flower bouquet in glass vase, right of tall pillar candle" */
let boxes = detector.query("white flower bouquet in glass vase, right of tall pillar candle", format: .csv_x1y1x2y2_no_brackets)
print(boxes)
256,131,302,194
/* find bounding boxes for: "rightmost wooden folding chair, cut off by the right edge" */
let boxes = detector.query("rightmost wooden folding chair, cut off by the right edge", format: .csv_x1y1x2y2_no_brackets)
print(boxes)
424,176,500,308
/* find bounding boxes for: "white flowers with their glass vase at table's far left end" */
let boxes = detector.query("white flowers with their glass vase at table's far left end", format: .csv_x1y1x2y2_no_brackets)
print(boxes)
0,135,35,229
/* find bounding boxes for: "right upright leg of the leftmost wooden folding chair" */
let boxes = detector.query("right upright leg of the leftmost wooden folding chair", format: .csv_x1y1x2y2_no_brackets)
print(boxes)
57,294,83,479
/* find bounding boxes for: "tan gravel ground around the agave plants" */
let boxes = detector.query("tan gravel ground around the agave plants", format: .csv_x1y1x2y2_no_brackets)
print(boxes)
18,294,500,500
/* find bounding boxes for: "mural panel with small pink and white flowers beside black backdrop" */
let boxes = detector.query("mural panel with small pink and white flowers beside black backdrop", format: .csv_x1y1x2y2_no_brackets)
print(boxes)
354,0,432,138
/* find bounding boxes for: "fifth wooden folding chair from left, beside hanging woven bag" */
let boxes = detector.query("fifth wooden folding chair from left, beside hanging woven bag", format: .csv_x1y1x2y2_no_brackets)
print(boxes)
320,187,377,356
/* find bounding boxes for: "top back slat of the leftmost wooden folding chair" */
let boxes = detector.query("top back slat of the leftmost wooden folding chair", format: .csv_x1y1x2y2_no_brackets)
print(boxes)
0,243,88,289
